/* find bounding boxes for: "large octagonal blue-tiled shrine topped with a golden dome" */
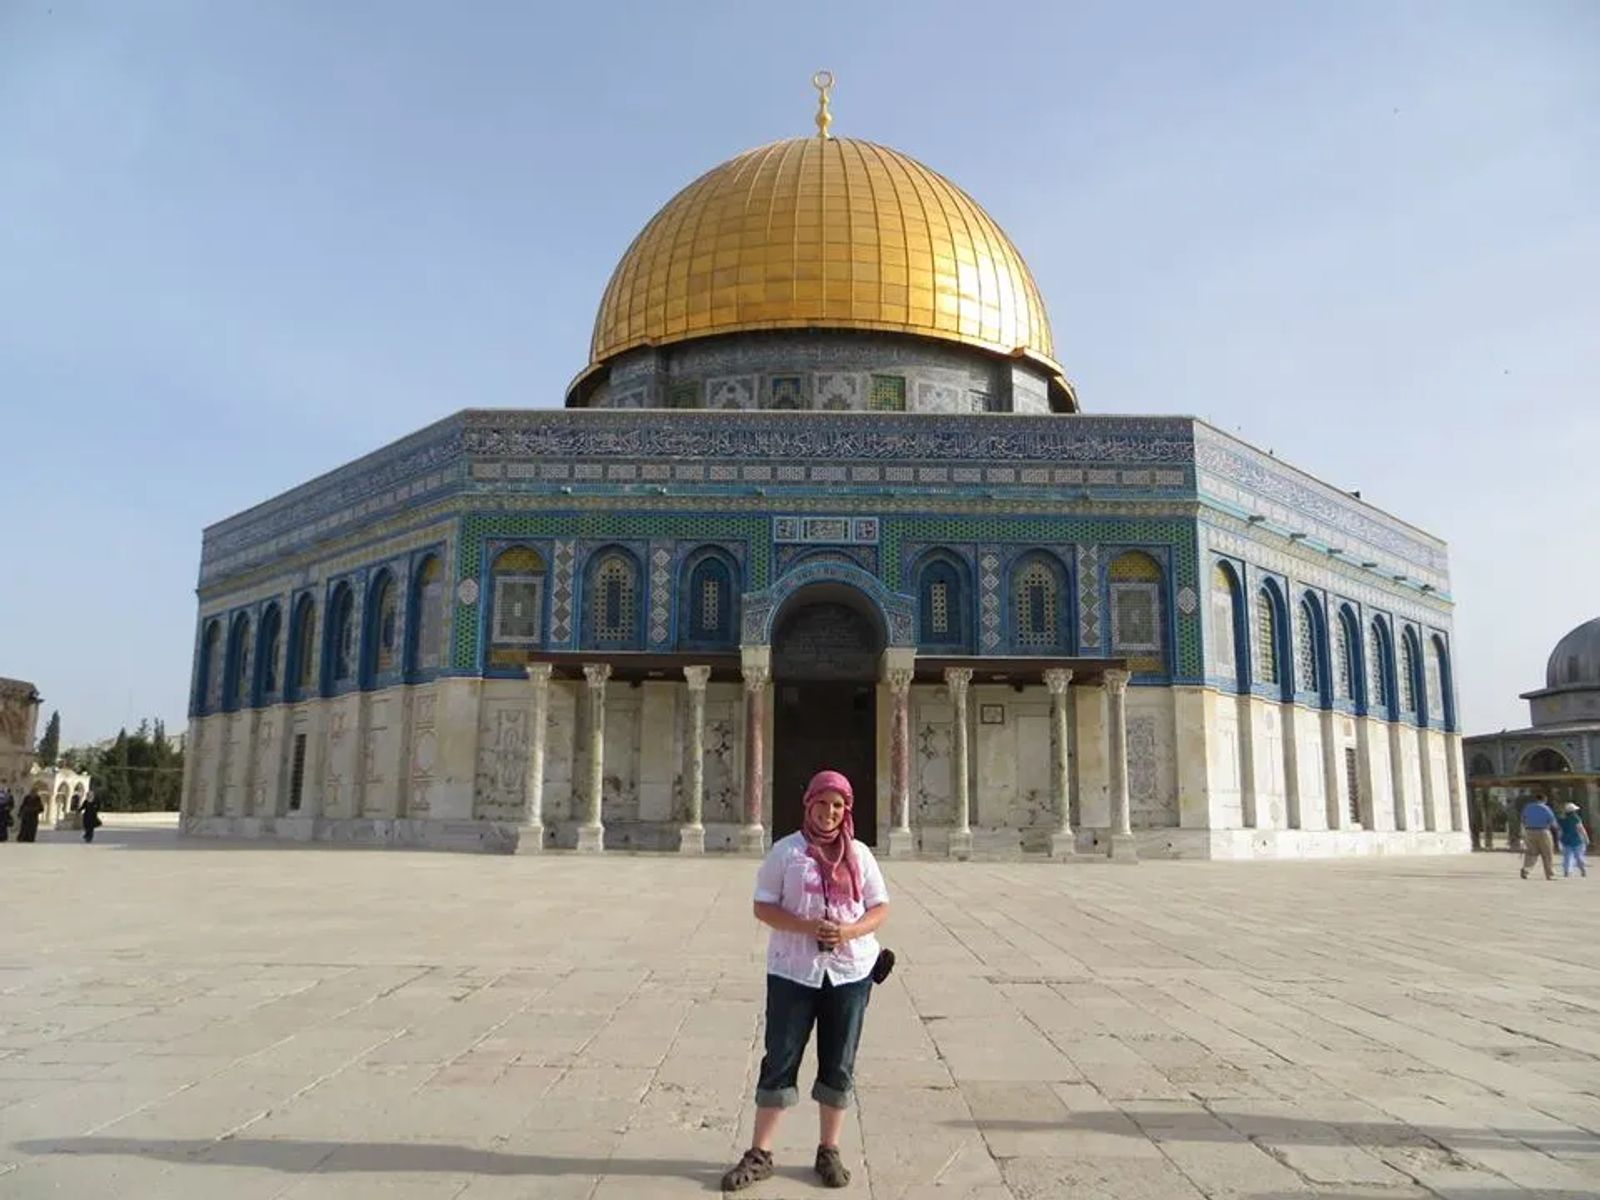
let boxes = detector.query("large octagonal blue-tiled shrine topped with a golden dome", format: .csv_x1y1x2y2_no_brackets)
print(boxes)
184,86,1467,858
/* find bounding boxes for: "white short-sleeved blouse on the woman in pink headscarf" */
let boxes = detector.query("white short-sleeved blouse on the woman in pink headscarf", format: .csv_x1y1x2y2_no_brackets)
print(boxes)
755,834,890,987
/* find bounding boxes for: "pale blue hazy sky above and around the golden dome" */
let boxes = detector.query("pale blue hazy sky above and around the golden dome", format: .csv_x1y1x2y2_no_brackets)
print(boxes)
0,0,1600,741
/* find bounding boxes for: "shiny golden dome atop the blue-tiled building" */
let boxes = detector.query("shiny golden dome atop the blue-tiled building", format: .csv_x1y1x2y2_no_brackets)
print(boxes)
586,136,1061,376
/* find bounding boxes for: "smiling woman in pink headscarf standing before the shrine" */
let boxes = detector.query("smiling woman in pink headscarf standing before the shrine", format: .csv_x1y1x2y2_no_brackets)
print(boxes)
722,771,890,1192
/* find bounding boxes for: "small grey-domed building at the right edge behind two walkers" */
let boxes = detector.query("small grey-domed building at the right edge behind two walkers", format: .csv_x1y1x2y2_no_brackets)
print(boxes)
1466,618,1600,846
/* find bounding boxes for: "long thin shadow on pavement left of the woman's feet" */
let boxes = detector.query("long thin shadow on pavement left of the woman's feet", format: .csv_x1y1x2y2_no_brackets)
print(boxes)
16,1138,728,1190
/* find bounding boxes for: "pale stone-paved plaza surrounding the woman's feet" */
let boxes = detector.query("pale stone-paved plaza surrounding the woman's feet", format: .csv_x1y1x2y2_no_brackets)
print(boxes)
0,816,1600,1200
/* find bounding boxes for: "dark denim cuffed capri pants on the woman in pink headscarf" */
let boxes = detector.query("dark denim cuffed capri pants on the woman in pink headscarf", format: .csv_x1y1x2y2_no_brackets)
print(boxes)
755,974,872,1109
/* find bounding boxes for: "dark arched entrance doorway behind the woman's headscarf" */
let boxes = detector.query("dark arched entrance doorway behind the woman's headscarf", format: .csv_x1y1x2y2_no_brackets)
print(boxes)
773,594,882,846
